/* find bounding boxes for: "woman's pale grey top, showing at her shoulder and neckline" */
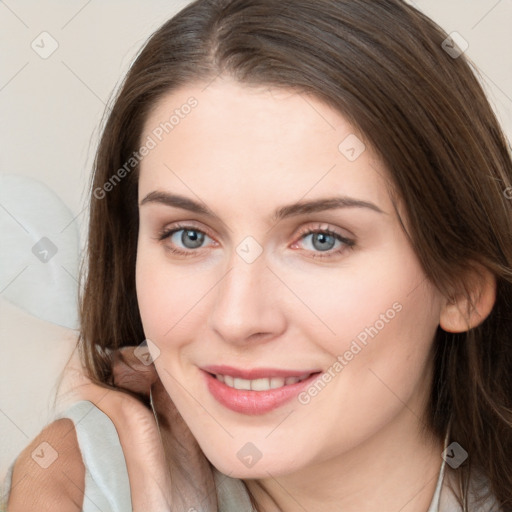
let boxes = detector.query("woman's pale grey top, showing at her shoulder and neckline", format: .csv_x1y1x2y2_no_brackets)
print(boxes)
0,400,500,512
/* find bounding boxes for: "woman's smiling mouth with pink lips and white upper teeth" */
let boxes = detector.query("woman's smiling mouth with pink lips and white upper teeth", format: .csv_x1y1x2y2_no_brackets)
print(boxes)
201,366,322,415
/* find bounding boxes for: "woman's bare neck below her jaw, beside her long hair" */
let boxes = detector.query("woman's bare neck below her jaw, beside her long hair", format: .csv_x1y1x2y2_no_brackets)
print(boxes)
245,408,444,512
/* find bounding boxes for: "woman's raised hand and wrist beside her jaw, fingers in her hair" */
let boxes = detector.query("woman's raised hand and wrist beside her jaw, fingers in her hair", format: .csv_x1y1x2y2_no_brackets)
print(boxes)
58,346,217,512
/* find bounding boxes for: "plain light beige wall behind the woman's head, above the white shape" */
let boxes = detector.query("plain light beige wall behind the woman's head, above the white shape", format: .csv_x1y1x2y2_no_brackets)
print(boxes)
0,0,512,236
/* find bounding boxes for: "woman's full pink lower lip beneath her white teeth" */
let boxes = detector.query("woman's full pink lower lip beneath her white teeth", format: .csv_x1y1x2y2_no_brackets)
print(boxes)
203,371,320,415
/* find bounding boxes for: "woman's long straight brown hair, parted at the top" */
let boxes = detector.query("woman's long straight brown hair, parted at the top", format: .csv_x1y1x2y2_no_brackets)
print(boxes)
80,0,512,510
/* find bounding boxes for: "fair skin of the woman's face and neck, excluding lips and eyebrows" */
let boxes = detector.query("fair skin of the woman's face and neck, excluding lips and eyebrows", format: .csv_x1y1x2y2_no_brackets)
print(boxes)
136,77,490,512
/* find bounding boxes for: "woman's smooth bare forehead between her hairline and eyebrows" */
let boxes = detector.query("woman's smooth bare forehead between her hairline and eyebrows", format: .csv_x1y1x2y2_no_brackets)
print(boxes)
139,75,389,210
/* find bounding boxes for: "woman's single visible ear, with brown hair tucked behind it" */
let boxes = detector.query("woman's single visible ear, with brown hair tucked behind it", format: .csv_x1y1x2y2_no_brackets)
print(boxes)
439,265,496,332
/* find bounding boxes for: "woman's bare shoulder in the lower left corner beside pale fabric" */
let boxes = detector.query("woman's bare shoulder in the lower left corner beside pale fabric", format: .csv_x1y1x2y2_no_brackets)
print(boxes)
8,418,85,512
